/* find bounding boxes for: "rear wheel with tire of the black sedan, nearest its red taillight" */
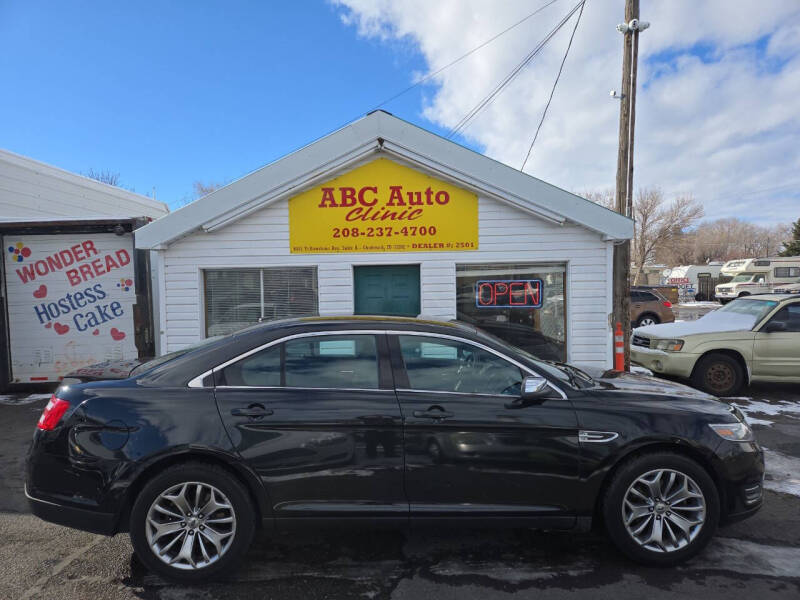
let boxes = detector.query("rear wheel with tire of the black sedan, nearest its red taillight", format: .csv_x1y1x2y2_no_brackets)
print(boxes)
130,462,256,583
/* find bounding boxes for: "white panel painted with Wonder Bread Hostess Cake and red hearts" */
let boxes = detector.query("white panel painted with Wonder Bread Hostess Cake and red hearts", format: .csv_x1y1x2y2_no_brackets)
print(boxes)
3,233,138,383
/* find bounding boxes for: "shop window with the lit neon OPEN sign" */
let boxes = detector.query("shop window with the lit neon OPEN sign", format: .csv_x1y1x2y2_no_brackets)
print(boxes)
456,263,567,361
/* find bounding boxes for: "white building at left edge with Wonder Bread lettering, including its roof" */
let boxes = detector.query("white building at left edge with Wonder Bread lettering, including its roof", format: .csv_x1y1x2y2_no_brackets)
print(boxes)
0,150,168,390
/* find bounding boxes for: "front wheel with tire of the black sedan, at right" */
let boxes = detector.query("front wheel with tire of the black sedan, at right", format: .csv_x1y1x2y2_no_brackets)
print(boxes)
602,452,720,567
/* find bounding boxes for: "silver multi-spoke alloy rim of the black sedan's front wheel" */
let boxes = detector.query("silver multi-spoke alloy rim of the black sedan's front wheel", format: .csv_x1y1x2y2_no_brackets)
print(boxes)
622,469,706,552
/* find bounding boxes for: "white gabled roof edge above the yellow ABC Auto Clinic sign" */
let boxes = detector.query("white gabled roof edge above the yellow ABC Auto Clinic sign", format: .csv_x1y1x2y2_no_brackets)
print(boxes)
136,111,633,249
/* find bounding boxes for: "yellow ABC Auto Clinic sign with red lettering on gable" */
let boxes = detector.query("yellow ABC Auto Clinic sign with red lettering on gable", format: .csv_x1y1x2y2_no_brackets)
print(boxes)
289,158,478,254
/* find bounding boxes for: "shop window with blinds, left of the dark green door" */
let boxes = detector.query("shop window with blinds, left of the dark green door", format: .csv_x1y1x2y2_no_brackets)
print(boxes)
203,267,319,337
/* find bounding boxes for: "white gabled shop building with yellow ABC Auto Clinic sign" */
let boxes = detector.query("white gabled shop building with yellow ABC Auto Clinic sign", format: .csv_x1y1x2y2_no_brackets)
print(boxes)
136,111,633,366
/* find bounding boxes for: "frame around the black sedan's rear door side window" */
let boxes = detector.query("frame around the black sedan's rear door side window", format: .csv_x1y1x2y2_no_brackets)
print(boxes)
198,329,394,392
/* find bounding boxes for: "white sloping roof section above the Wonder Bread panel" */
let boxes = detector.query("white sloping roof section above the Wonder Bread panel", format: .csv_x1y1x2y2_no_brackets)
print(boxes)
0,150,169,222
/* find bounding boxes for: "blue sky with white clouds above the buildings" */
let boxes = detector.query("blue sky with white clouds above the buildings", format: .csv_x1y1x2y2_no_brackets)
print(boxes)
0,0,800,224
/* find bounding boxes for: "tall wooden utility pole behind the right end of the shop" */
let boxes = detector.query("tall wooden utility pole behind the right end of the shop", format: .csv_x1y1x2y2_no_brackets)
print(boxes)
612,0,650,370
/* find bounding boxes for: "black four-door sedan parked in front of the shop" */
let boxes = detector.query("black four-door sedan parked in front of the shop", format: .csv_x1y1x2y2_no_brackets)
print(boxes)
26,317,764,581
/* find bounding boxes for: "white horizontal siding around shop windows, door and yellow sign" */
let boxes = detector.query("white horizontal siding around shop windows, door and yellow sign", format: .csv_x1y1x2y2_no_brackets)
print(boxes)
162,197,612,366
